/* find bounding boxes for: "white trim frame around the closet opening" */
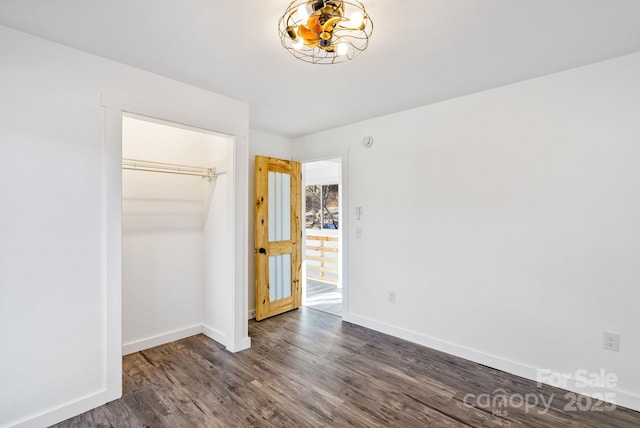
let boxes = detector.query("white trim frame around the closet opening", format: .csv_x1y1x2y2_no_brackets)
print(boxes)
101,93,251,402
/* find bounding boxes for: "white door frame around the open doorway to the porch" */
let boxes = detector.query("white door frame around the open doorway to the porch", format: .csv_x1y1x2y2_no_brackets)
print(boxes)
296,148,351,321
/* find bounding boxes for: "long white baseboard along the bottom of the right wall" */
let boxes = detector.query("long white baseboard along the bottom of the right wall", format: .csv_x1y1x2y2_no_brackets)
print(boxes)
342,313,640,411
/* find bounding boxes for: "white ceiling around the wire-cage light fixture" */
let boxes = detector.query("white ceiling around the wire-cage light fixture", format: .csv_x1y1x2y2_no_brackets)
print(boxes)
0,0,640,137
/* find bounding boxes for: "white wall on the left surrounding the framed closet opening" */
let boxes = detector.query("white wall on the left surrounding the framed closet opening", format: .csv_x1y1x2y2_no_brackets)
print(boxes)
0,27,248,426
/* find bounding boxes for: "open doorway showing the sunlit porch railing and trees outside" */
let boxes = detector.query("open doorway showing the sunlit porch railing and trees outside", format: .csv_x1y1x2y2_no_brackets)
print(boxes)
302,158,343,316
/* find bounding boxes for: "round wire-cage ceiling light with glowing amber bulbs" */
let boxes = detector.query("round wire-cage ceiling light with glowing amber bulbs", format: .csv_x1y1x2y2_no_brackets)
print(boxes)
278,0,373,64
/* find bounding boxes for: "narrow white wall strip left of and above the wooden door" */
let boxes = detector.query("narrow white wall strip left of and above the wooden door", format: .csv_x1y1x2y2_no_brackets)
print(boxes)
248,129,292,318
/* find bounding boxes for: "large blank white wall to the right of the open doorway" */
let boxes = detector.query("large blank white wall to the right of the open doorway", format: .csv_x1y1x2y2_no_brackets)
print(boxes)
294,53,640,410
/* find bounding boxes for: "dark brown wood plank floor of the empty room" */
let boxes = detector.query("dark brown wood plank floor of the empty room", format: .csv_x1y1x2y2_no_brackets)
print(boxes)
51,308,640,428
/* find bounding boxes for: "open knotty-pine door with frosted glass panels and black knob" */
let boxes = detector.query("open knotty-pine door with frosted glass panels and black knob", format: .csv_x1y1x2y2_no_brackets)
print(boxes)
255,156,302,321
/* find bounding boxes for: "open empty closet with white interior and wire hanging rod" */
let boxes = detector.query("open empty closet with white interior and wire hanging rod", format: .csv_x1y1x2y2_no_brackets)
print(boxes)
122,113,234,355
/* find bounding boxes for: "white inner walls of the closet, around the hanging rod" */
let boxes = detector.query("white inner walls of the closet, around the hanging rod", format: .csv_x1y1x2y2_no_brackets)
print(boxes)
122,117,231,354
